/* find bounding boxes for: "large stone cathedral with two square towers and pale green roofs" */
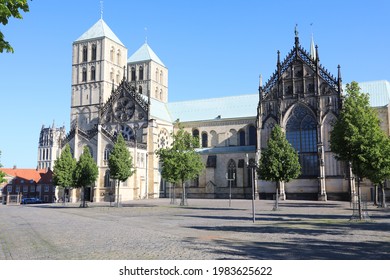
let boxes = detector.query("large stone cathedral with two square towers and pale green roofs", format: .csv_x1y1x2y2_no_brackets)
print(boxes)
38,19,390,202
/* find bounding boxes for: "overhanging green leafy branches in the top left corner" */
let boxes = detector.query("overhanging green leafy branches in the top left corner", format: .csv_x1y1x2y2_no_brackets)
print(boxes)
0,0,29,53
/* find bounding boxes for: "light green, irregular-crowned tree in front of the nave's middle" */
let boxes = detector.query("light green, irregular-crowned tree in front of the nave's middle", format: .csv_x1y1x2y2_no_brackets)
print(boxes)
156,127,204,206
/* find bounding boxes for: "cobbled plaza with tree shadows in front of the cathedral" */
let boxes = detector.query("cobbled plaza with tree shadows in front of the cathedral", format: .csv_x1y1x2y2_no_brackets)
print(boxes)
0,199,390,260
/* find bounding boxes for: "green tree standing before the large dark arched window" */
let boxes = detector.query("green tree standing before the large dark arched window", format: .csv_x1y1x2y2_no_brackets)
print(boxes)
257,125,301,210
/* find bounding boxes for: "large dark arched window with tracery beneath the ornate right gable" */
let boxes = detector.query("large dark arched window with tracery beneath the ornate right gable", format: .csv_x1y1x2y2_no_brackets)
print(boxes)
286,105,319,177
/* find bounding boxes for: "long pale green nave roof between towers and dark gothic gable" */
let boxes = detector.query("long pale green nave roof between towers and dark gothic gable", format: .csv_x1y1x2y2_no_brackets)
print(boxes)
167,94,259,122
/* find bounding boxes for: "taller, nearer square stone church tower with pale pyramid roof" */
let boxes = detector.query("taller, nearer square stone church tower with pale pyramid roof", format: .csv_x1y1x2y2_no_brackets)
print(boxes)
70,19,127,130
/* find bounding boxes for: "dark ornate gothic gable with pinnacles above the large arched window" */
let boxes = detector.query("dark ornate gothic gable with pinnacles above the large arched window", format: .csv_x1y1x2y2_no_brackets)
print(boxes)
259,34,342,126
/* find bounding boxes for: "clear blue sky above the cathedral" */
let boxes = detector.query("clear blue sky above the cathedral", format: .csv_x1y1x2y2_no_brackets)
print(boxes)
0,0,390,168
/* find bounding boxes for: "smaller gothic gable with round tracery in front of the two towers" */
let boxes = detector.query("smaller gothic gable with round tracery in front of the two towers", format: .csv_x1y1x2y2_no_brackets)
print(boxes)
100,80,149,143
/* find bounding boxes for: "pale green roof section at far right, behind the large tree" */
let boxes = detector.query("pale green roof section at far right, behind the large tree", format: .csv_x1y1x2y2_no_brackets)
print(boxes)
343,80,390,107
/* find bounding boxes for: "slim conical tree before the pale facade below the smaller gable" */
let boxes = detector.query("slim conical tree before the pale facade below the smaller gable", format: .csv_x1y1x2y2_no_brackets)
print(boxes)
108,134,135,206
